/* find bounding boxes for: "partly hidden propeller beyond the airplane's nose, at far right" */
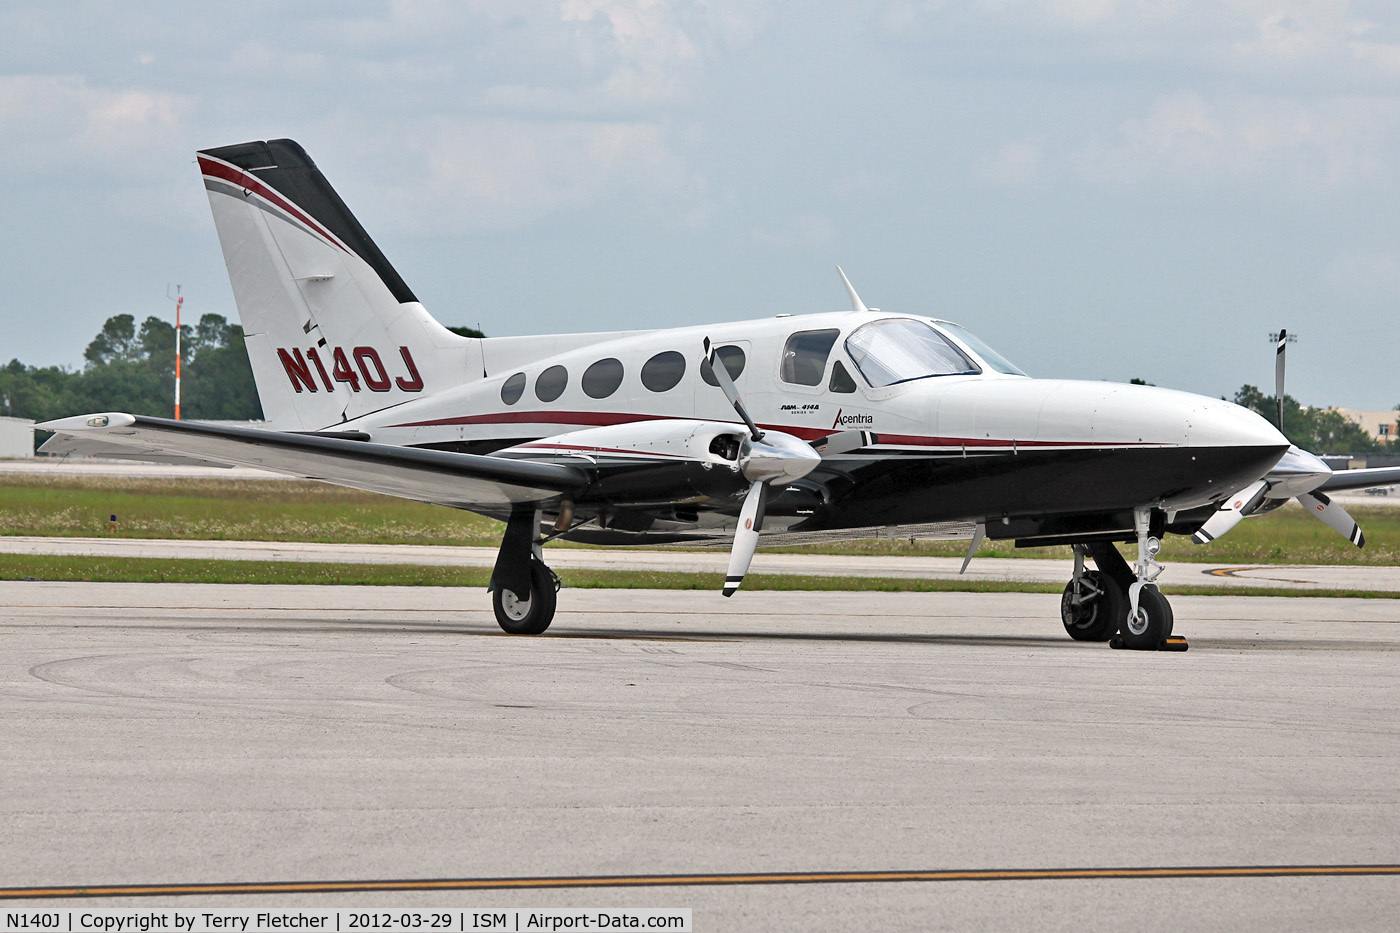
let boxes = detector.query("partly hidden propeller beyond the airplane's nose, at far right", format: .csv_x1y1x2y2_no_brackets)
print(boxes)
1191,329,1366,548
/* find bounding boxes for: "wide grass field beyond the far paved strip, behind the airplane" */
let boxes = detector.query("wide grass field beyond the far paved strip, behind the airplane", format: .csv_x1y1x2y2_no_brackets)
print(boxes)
0,475,1400,566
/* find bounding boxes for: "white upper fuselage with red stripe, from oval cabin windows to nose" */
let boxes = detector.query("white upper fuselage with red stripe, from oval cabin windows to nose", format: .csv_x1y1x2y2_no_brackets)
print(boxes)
344,311,1287,507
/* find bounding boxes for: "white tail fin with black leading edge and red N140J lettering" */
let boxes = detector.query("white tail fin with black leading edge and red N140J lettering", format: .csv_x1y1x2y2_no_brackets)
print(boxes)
199,139,482,430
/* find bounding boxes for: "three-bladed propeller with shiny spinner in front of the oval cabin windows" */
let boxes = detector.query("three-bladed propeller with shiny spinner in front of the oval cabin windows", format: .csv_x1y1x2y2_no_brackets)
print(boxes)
704,338,823,597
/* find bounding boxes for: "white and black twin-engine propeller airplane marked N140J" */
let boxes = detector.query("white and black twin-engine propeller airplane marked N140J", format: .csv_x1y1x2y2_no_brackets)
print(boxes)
41,139,1400,649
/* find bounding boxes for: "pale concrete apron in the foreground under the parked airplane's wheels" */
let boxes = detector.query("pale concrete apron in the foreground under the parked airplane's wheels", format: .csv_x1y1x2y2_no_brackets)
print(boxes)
0,583,1400,930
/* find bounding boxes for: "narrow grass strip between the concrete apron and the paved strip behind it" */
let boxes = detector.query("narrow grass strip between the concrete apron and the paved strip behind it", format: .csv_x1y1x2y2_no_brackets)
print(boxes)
0,555,1400,600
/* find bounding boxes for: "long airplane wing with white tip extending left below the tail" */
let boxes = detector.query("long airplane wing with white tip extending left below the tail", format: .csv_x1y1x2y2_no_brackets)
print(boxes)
36,412,591,509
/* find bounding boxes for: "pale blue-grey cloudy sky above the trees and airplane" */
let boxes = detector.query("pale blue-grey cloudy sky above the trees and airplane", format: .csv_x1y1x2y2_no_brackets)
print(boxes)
0,0,1400,408
